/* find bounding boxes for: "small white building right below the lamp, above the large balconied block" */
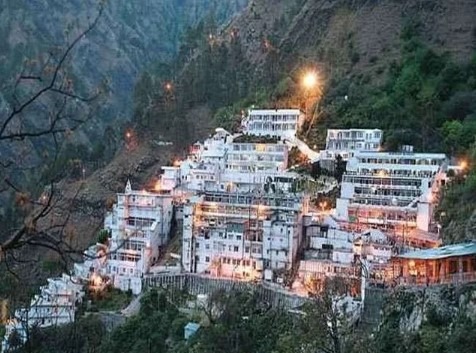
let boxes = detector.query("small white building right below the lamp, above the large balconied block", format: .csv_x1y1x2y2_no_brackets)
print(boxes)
320,129,383,167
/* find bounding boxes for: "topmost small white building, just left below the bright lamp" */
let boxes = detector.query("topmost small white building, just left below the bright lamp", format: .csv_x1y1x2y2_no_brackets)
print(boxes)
242,109,305,139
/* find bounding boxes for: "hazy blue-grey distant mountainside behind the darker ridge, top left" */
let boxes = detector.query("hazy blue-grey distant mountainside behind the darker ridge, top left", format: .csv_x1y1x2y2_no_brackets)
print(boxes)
0,0,247,153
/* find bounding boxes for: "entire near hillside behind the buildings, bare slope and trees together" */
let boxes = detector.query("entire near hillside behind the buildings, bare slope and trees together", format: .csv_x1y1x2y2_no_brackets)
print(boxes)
135,0,476,241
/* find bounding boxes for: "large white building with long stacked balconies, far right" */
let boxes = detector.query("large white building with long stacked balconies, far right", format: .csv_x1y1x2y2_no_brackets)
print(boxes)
336,148,446,235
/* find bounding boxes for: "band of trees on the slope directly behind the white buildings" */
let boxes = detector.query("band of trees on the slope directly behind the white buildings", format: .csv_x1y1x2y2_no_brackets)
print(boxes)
134,18,476,242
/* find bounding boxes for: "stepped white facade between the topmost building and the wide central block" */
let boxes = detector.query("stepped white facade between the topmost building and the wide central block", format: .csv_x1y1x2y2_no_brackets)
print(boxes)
175,129,299,192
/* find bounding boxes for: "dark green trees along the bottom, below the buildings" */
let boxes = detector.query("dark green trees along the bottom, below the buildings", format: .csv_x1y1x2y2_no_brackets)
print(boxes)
7,282,476,353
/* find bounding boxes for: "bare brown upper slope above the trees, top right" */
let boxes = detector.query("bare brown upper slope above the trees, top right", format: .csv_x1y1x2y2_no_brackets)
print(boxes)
227,0,476,73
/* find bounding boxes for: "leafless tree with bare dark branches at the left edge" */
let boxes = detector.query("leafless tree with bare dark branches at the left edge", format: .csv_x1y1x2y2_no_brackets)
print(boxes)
0,6,105,267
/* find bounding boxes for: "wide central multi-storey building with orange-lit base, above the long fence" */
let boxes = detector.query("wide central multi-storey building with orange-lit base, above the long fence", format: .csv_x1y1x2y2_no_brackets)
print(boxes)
182,192,307,279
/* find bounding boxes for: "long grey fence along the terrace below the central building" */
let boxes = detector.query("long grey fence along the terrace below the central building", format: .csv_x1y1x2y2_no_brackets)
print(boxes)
143,273,308,309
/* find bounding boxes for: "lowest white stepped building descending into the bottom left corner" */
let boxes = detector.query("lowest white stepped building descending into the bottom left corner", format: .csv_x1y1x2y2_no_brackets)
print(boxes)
2,274,84,352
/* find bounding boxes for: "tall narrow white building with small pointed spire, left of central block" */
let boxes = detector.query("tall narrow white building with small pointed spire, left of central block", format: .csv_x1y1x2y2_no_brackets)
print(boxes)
104,182,173,294
